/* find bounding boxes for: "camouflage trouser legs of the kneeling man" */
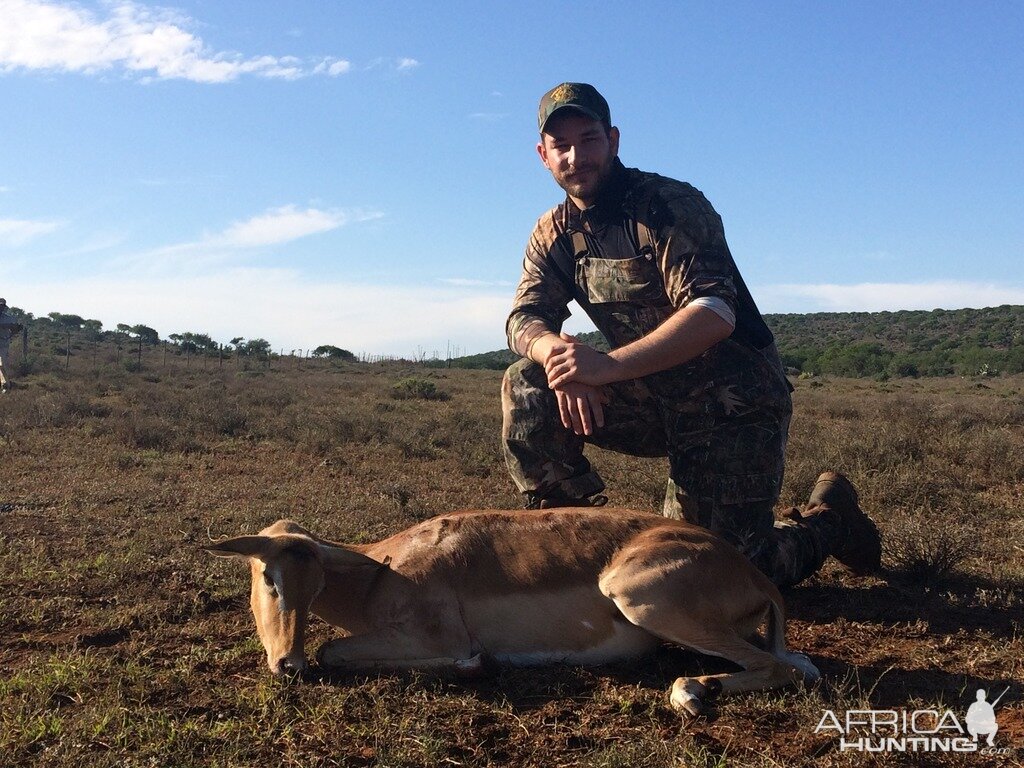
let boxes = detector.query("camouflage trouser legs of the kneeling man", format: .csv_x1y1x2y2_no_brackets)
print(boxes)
502,359,840,587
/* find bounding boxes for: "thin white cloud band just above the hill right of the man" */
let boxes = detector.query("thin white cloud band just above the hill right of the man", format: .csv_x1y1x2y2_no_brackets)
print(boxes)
753,281,1024,313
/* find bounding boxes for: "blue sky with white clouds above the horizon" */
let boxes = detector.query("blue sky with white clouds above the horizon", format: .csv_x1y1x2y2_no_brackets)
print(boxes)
0,0,1024,355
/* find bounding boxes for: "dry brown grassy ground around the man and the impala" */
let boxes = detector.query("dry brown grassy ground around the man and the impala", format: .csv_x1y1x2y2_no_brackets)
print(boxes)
0,365,1024,767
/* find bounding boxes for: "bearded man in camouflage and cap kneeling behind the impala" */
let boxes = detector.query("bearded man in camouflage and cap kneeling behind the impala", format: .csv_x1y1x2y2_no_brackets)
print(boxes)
502,83,881,586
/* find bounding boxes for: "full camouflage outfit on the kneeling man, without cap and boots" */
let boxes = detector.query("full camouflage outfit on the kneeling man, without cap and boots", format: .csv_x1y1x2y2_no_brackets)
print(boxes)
502,160,839,585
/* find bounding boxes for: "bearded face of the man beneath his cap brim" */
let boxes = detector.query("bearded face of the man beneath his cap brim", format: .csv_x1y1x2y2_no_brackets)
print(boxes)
537,110,618,208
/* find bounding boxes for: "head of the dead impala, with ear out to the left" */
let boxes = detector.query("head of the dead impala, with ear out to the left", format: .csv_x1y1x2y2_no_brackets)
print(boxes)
205,520,324,675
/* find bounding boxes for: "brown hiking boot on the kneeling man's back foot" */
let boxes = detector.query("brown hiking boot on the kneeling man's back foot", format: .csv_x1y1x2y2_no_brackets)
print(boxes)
804,472,882,575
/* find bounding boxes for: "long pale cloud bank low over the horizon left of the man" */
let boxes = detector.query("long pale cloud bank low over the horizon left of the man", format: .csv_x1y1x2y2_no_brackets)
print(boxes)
0,266,511,356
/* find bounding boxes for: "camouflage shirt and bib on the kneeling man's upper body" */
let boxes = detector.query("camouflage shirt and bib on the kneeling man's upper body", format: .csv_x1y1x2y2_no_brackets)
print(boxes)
506,160,788,417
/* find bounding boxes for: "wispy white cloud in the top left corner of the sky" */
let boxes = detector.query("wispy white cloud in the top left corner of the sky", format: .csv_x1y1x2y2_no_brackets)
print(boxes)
0,0,347,83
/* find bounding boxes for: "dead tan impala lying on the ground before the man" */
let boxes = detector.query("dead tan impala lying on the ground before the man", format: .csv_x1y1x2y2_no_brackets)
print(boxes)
207,508,818,715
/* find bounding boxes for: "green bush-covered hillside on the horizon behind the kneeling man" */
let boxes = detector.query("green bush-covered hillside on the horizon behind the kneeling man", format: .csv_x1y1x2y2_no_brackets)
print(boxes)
452,305,1024,378
